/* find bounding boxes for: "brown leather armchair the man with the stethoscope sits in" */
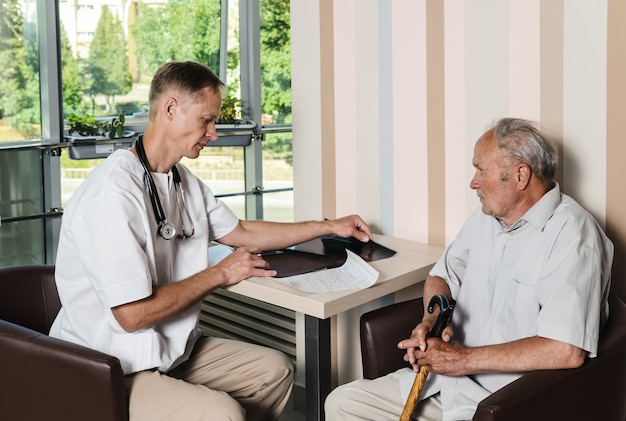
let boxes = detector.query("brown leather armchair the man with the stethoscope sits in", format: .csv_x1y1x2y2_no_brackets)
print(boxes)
0,265,128,421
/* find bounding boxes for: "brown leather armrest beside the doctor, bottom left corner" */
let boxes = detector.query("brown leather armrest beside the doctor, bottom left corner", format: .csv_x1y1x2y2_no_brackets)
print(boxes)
0,320,128,421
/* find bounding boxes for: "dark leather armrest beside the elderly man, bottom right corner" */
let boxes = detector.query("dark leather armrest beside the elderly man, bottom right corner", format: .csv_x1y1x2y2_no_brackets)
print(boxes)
473,294,626,421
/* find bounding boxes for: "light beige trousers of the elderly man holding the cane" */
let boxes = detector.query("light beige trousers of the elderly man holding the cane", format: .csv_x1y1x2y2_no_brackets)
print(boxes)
324,372,443,421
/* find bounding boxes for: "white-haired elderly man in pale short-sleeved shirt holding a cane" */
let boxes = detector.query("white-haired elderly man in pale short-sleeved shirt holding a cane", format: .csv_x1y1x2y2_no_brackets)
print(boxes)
326,118,613,421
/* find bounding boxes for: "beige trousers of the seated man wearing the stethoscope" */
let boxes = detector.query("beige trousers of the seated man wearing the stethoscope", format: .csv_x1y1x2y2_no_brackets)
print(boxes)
126,337,294,421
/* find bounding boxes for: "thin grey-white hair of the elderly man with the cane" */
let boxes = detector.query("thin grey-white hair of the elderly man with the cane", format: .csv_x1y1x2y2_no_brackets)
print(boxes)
494,118,559,181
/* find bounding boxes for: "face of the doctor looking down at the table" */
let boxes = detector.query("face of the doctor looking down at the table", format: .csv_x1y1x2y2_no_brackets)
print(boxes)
170,87,222,159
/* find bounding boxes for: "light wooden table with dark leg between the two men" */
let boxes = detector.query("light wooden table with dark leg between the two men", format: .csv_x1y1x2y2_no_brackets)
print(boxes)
228,234,444,421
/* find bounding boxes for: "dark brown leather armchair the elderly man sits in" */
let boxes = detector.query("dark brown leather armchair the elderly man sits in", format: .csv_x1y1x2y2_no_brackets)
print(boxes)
360,294,626,421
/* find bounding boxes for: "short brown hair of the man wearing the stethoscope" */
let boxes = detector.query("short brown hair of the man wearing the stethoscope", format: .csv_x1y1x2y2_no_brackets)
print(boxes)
148,61,224,118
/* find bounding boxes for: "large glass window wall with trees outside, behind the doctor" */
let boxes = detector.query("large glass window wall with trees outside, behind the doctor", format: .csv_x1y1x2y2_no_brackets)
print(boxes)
0,0,293,266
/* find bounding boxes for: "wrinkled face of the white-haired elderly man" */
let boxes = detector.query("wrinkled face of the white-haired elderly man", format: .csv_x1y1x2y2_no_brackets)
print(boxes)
470,131,518,225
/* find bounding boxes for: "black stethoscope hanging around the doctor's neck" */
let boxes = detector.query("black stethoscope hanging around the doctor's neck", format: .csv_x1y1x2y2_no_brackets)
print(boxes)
135,135,194,240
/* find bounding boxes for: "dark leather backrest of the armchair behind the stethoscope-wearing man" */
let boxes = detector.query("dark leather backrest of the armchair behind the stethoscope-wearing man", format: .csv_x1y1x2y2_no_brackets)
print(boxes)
0,265,61,335
